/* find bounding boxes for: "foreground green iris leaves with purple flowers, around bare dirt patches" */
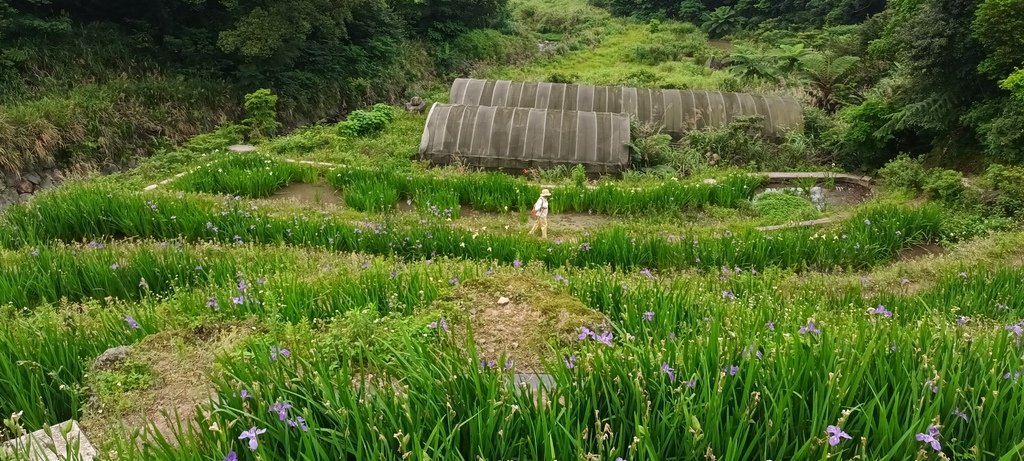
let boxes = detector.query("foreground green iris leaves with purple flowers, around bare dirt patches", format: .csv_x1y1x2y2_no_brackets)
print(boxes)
0,232,1024,459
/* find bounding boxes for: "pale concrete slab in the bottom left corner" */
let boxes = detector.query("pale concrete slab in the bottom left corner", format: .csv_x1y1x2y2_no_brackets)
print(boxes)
0,420,96,461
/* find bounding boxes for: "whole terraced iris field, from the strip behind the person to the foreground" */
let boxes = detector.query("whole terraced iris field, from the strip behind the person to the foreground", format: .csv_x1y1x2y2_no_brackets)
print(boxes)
0,137,1024,460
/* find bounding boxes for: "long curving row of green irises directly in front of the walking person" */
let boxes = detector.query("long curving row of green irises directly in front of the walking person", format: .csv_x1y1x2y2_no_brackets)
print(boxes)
0,185,943,269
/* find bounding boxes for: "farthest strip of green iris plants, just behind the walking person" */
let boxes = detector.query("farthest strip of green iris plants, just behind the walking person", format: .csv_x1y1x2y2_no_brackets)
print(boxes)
163,154,766,217
